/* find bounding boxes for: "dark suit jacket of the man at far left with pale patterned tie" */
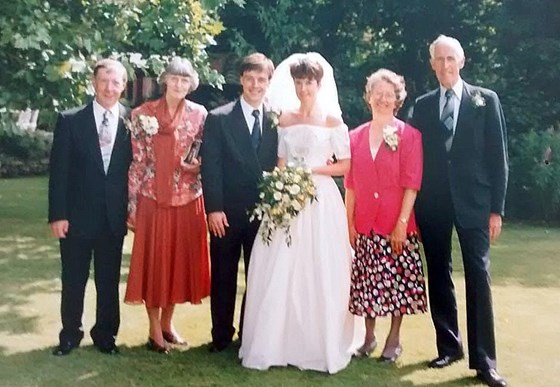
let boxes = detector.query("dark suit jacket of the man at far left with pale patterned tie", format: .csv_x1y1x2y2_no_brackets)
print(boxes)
49,103,132,238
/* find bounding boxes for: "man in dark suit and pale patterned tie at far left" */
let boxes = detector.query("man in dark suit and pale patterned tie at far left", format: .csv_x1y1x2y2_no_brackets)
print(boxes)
49,59,132,356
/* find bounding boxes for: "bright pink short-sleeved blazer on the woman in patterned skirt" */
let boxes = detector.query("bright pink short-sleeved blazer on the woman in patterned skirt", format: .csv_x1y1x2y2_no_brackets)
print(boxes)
344,118,422,235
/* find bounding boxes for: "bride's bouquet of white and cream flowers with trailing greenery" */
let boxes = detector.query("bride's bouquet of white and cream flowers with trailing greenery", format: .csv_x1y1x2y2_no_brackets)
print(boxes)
250,166,317,246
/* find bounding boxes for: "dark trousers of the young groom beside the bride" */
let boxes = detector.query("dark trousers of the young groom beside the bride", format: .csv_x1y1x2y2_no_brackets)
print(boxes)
210,216,259,346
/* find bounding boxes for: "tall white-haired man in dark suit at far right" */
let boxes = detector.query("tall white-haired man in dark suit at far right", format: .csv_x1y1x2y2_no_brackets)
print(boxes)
412,35,508,386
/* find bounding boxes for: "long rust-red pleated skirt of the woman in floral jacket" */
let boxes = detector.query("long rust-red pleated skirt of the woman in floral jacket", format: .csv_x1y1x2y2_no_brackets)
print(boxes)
124,196,210,308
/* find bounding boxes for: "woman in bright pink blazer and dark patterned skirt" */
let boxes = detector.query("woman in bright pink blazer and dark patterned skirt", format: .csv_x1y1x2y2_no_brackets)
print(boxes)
345,69,427,362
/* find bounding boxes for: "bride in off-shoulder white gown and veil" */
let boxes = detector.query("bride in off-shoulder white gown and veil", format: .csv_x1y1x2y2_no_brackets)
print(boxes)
239,53,361,373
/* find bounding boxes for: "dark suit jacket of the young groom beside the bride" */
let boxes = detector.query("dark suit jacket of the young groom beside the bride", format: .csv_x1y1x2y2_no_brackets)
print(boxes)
201,100,278,218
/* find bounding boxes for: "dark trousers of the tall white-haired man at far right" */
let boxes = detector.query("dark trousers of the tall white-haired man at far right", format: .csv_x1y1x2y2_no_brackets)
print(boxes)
419,216,496,370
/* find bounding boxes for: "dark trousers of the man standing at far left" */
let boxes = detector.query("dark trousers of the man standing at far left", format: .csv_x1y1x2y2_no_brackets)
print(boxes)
59,235,124,347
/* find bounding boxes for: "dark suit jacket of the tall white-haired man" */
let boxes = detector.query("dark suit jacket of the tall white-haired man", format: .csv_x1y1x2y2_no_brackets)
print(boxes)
411,82,508,228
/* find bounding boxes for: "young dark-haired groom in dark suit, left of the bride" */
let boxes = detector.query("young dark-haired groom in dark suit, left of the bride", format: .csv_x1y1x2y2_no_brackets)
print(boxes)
201,53,278,352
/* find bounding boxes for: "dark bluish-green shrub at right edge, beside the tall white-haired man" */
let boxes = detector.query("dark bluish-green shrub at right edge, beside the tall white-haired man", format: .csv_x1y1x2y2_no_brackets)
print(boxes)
507,129,560,221
